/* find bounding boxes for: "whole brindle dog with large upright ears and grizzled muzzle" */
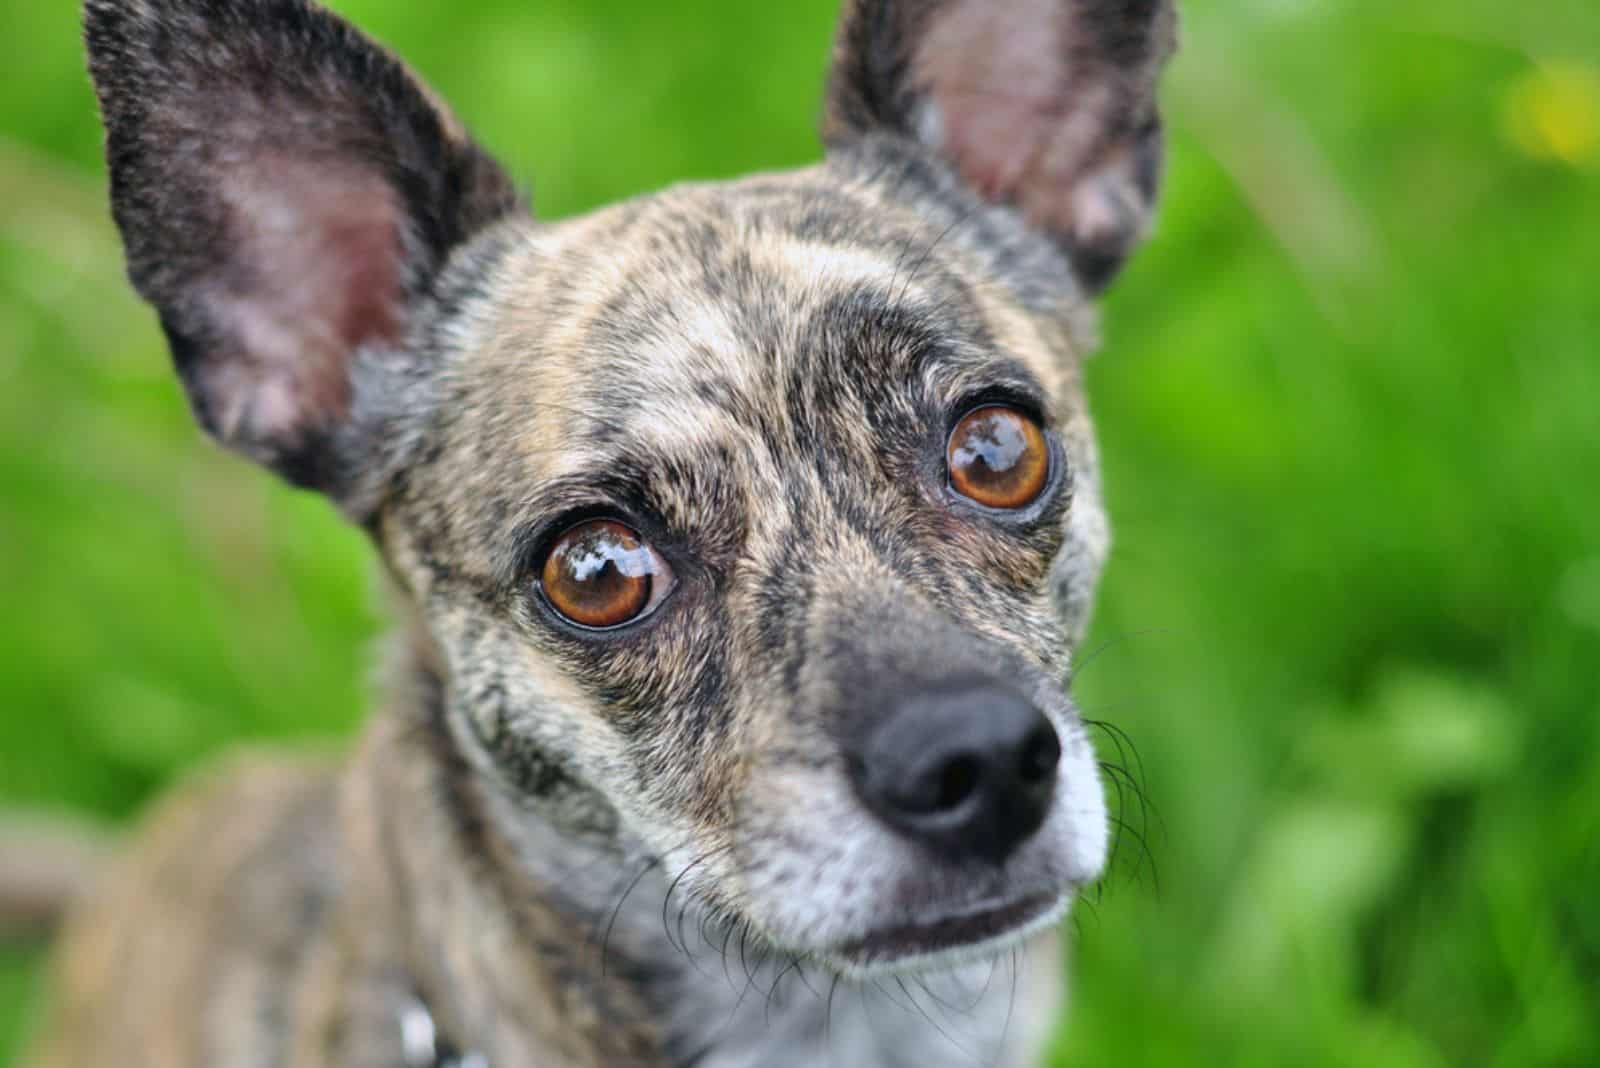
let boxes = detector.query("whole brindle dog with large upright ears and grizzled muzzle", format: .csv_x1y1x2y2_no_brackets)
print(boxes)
15,0,1176,1068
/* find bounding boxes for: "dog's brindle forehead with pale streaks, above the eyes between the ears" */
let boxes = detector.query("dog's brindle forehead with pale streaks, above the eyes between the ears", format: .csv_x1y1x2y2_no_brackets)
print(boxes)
469,166,1070,475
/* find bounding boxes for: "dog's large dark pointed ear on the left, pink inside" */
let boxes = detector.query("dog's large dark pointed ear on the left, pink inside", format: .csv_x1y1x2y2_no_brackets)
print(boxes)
85,0,517,494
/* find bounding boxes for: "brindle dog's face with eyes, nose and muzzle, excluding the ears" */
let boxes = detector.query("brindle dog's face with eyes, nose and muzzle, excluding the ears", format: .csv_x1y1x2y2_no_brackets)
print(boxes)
381,163,1106,964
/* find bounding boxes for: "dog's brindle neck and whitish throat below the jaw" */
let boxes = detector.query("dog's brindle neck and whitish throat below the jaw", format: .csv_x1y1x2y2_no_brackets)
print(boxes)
342,620,1058,1068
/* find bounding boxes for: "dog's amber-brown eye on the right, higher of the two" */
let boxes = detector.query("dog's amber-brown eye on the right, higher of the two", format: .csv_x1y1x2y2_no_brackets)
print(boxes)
947,404,1050,510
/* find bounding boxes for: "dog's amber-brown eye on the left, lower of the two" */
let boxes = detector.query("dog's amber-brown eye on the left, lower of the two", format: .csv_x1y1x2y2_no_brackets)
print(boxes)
539,520,672,630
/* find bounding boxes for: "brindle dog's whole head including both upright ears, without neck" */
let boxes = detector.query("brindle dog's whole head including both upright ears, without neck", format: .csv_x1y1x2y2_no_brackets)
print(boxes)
88,0,1173,970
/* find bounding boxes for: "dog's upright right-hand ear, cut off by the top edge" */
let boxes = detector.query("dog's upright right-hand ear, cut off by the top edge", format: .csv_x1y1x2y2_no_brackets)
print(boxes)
822,0,1176,289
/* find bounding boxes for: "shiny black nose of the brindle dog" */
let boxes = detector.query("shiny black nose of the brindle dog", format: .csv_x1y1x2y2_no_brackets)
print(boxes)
851,686,1061,863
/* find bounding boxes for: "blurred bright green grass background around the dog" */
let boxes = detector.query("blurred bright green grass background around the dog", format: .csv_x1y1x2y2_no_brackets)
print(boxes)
0,0,1600,1068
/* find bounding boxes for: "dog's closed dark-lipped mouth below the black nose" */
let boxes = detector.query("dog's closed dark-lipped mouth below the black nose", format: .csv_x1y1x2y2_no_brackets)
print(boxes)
829,891,1070,972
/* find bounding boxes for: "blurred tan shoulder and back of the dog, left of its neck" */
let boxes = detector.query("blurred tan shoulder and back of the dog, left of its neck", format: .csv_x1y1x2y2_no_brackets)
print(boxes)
37,753,341,1068
